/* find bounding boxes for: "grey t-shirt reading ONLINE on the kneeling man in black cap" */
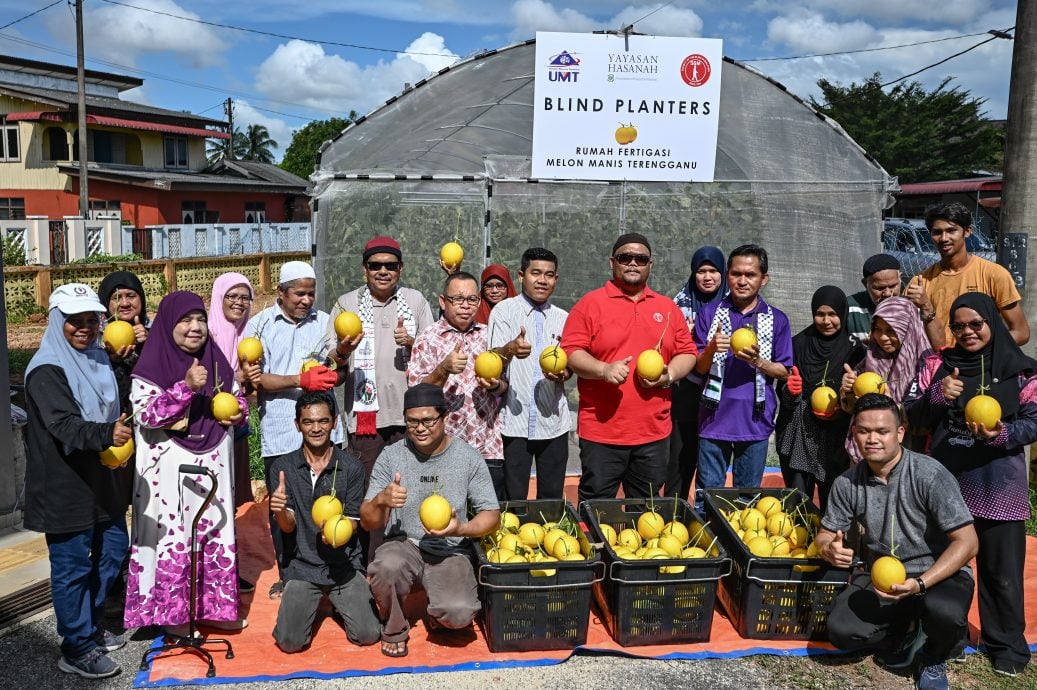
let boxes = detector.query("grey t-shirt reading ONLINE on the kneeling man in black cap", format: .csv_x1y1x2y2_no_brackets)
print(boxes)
364,437,500,555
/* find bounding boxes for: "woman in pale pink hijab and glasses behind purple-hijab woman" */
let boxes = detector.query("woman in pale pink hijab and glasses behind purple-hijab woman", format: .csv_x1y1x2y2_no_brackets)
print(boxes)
208,273,260,507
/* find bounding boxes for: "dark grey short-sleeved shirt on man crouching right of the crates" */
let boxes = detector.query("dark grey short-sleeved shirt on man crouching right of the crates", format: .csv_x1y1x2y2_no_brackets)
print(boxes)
821,448,973,577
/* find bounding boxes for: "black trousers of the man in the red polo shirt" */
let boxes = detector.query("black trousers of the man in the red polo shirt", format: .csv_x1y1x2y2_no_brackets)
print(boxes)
580,436,670,502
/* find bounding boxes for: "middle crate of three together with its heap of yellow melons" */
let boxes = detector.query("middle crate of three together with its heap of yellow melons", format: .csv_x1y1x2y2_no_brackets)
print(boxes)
581,498,731,646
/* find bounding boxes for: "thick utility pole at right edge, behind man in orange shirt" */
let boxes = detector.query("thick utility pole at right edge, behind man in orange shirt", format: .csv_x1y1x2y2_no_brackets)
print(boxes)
999,2,1037,332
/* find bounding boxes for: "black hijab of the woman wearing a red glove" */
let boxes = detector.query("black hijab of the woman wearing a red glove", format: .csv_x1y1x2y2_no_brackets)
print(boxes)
792,285,864,397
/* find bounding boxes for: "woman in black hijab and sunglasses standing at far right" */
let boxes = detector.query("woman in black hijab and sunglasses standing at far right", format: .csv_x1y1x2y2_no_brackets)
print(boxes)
907,293,1037,675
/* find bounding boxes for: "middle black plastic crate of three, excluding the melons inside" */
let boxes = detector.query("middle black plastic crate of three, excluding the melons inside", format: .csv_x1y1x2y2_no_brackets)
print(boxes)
581,498,731,646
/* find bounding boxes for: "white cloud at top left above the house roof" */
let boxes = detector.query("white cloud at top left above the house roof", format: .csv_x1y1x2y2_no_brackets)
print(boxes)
45,0,228,67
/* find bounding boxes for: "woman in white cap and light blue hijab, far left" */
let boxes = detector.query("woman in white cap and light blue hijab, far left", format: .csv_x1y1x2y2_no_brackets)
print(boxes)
25,283,133,678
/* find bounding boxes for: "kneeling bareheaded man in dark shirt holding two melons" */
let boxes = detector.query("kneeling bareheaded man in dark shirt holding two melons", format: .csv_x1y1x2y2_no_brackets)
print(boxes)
267,391,381,653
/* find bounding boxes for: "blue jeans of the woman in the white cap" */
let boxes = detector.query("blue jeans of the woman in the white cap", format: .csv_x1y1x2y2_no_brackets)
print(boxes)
47,520,130,659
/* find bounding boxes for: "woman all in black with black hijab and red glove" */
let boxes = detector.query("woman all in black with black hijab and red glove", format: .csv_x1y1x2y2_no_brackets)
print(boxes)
775,285,864,514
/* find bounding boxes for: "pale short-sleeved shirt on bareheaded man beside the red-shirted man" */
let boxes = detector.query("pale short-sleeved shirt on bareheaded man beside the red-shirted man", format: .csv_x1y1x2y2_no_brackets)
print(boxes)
489,295,572,441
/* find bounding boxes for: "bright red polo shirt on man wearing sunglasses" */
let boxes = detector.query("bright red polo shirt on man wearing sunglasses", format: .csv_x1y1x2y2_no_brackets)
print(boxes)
562,280,698,445
